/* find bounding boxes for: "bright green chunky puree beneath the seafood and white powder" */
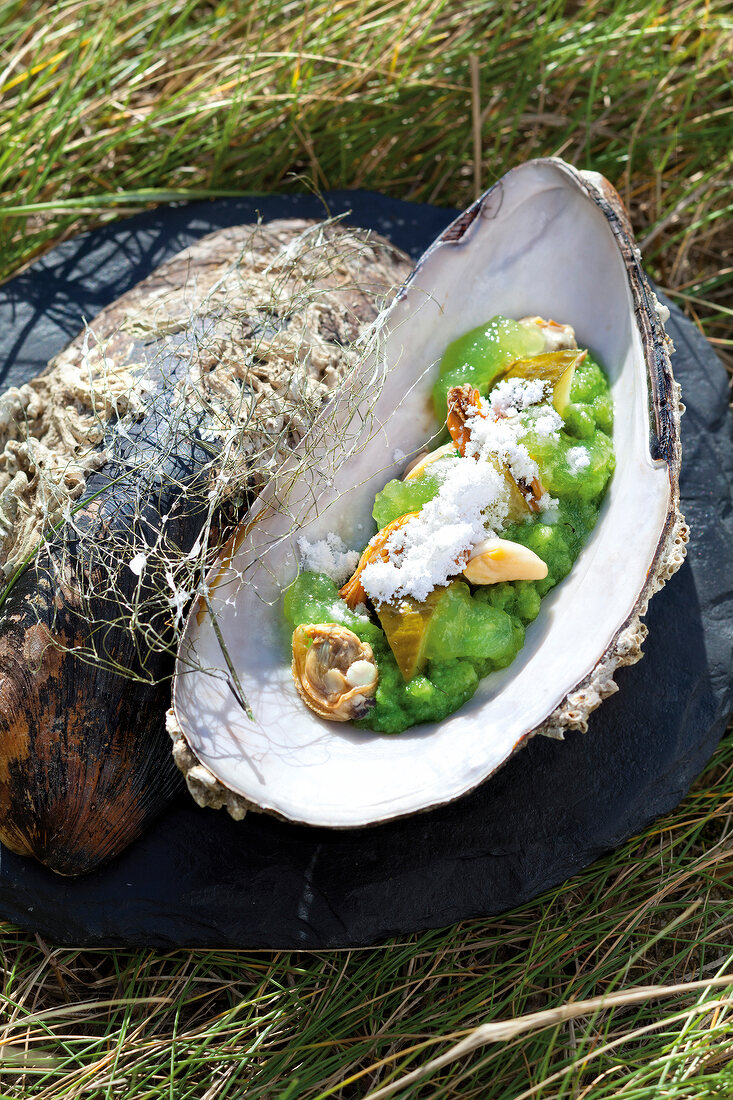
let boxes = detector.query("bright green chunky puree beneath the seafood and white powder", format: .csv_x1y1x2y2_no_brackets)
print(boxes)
284,318,614,734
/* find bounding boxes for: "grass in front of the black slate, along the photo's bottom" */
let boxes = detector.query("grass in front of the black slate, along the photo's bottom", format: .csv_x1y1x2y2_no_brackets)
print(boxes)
0,739,733,1100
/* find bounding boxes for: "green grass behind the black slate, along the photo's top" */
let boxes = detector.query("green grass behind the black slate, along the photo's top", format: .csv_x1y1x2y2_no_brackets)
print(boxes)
0,0,733,356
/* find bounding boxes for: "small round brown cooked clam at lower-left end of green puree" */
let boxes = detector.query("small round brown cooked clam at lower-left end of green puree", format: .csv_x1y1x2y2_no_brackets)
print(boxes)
293,623,379,722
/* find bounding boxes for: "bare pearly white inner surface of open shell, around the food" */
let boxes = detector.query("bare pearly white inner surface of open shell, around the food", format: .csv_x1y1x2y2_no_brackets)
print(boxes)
174,161,687,826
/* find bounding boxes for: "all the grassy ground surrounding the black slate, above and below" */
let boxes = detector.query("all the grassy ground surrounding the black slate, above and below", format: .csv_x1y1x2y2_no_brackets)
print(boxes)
0,0,733,1100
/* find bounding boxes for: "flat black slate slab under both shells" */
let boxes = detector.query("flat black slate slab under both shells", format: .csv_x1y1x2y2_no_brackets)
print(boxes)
0,191,733,948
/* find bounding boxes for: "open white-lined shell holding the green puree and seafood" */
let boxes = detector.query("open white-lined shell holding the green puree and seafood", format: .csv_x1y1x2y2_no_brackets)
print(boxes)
168,158,688,827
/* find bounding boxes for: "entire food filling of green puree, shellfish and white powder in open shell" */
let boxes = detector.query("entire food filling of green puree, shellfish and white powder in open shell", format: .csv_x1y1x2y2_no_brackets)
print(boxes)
284,317,614,733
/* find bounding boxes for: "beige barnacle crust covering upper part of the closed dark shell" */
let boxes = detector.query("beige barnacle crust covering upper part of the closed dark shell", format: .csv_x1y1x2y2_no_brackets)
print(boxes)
0,219,409,576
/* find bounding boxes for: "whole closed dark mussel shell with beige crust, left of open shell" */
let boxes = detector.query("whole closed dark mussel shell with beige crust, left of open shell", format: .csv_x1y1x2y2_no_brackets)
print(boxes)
0,220,409,875
